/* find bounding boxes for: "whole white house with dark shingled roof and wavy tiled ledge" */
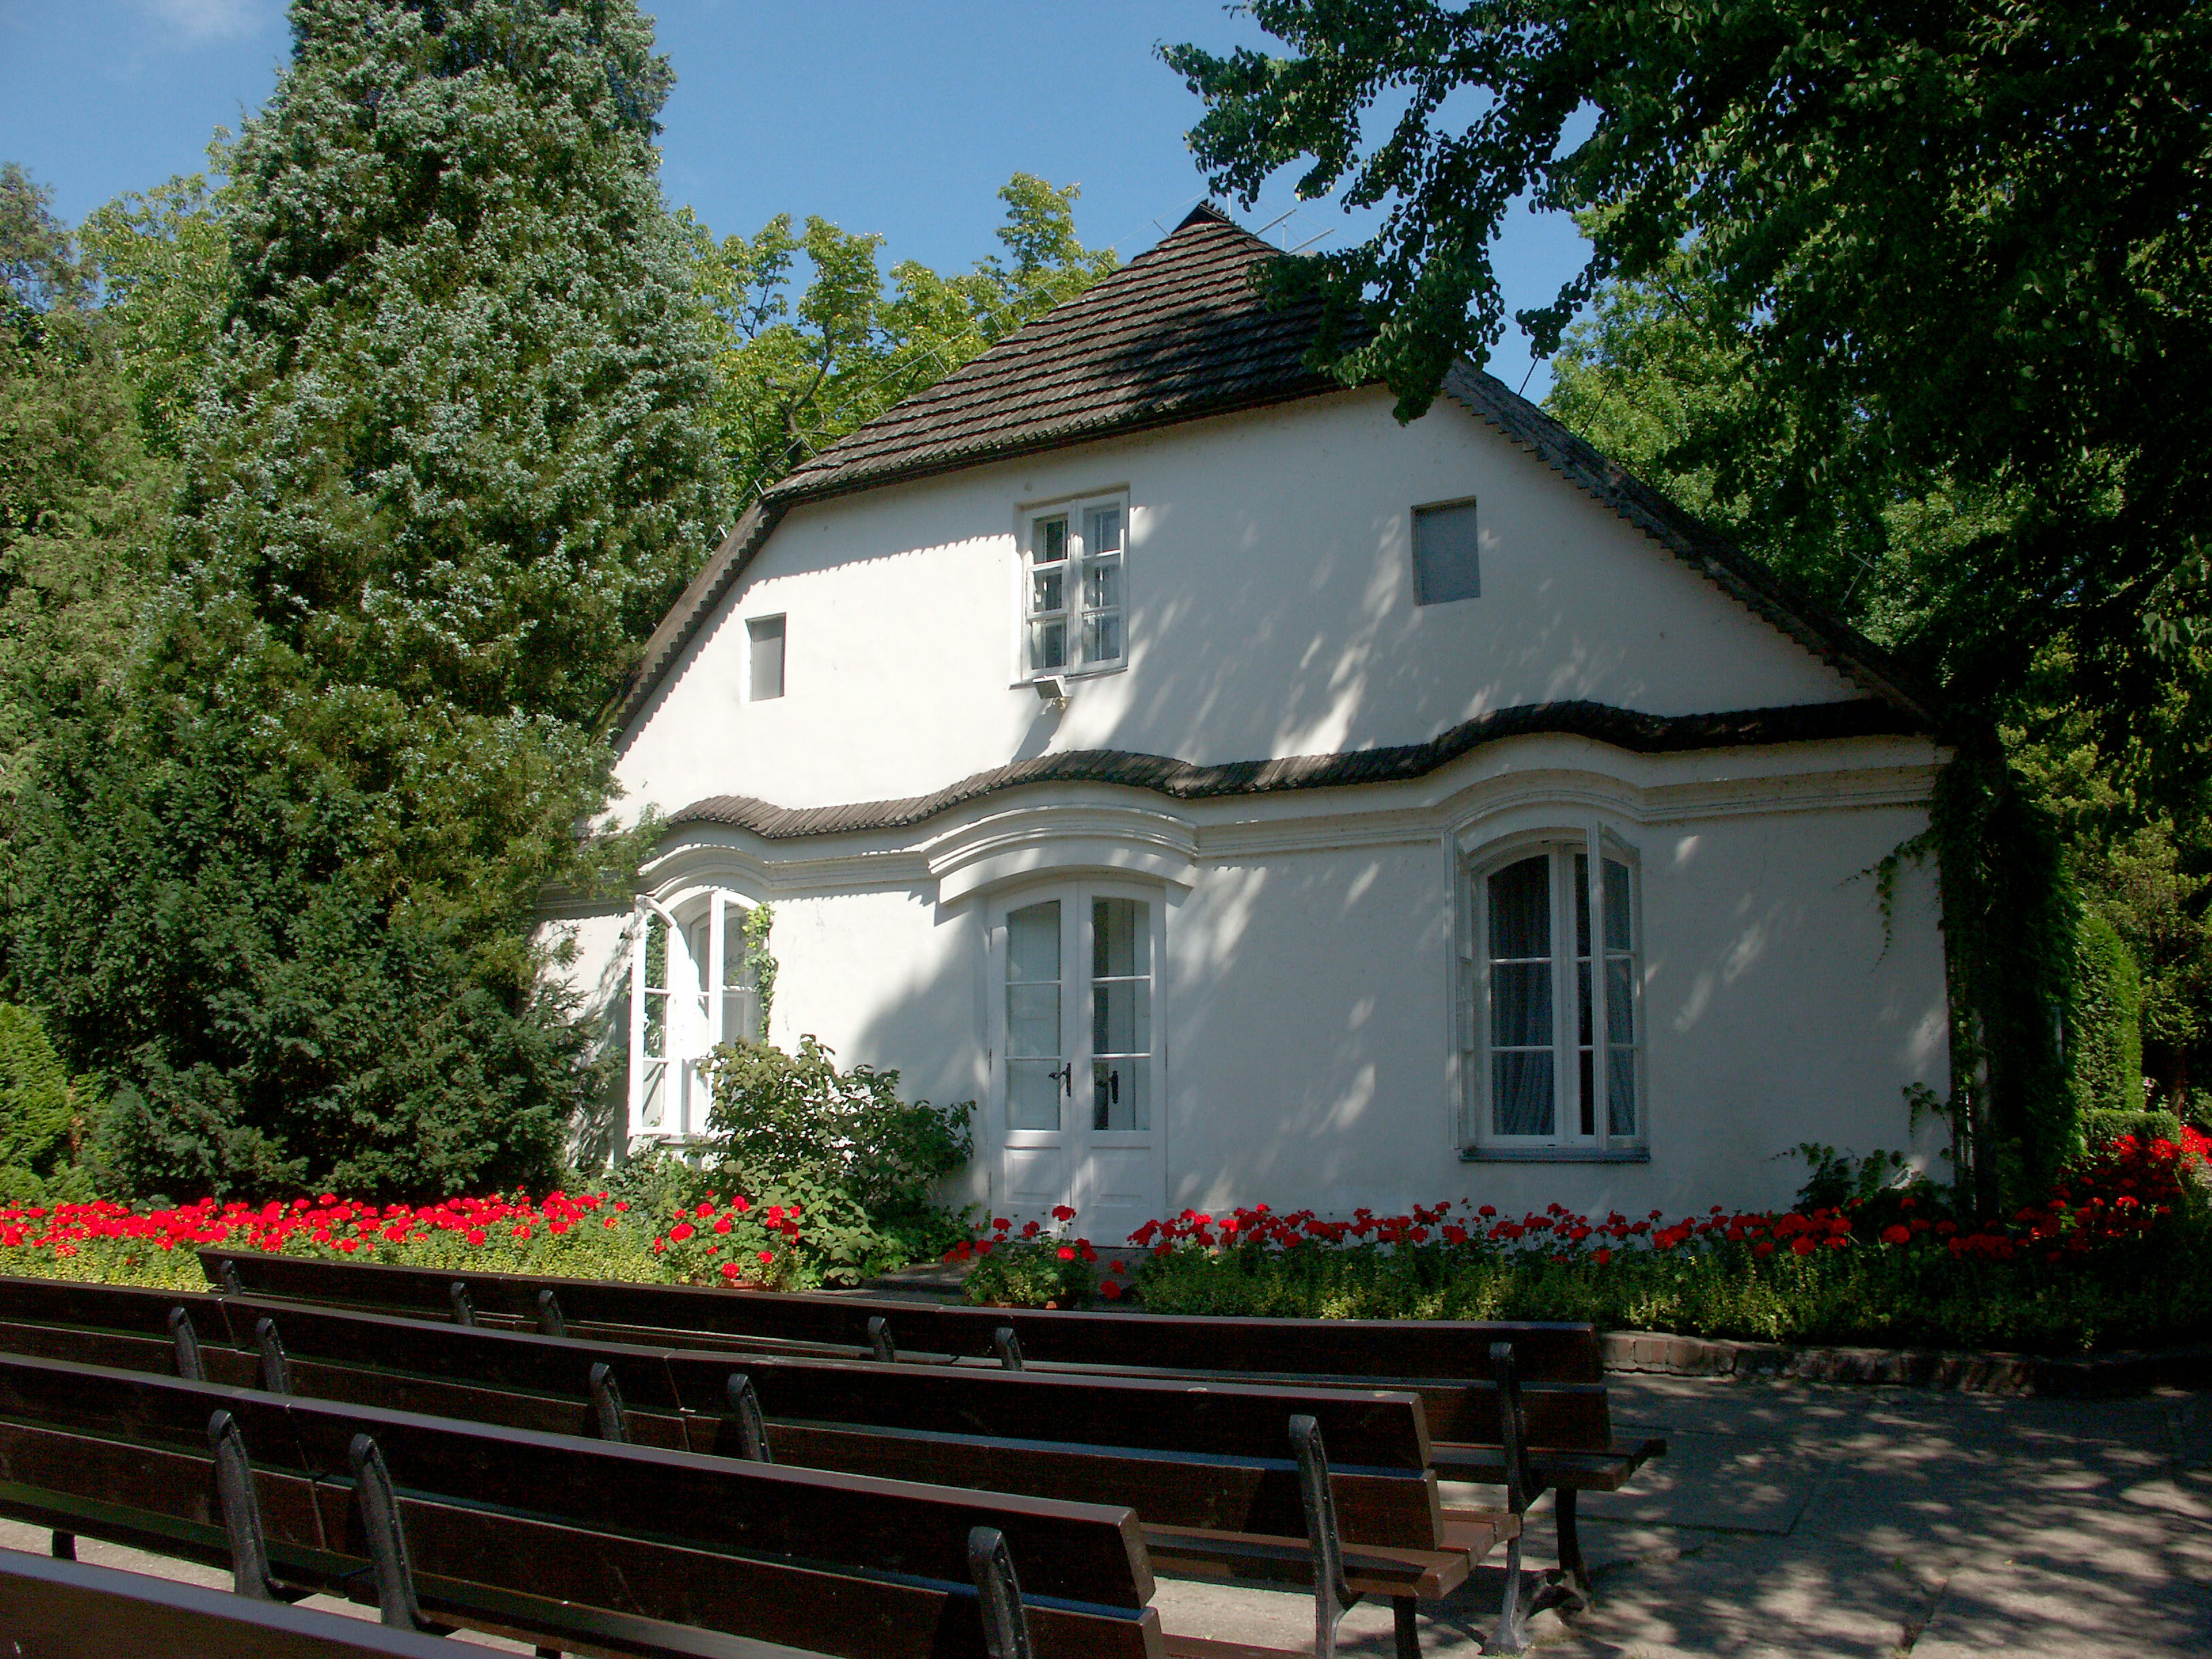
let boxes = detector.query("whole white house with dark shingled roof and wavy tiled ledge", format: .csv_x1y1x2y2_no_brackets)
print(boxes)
564,208,1949,1241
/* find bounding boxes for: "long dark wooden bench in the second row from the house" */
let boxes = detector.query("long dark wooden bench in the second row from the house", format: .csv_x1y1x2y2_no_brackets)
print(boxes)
0,1279,1517,1652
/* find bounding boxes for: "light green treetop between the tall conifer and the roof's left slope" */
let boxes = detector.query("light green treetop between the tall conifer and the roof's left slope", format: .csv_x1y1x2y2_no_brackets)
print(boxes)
690,173,1115,505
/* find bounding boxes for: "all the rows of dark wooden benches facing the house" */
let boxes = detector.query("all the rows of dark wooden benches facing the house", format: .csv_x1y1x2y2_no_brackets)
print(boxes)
0,1254,1659,1659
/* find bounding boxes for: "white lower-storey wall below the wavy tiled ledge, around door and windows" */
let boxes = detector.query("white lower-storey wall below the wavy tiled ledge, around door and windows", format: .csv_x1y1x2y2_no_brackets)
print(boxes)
539,739,1949,1214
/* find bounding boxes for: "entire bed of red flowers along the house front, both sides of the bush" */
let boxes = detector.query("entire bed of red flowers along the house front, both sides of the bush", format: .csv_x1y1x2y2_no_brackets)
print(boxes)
0,1130,2212,1354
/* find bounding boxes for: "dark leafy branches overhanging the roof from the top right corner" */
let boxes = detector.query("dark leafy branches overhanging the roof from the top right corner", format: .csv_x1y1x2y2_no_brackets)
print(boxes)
1166,0,2212,734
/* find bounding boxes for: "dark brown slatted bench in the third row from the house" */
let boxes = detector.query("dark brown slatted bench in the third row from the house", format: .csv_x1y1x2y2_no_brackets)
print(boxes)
0,1356,1161,1659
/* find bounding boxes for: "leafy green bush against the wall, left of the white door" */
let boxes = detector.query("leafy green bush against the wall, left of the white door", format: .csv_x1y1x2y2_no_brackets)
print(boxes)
706,1035,975,1281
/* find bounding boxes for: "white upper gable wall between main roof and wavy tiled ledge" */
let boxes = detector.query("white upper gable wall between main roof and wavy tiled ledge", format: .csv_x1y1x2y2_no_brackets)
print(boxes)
619,378,1862,809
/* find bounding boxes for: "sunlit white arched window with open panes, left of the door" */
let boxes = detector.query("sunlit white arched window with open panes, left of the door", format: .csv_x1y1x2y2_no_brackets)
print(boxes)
630,889,761,1141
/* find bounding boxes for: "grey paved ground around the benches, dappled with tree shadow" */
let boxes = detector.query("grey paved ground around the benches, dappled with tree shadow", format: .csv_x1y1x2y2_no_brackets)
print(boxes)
17,1376,2212,1659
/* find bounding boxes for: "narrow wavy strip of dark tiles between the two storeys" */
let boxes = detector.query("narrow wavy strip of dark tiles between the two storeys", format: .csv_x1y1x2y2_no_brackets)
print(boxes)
668,697,1920,840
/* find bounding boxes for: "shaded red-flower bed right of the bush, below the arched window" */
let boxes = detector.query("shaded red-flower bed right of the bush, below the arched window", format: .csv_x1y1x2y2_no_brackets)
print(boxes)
953,1130,2212,1354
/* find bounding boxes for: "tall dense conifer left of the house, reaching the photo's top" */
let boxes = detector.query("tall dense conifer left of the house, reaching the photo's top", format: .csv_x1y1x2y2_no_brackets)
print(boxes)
11,0,721,1195
